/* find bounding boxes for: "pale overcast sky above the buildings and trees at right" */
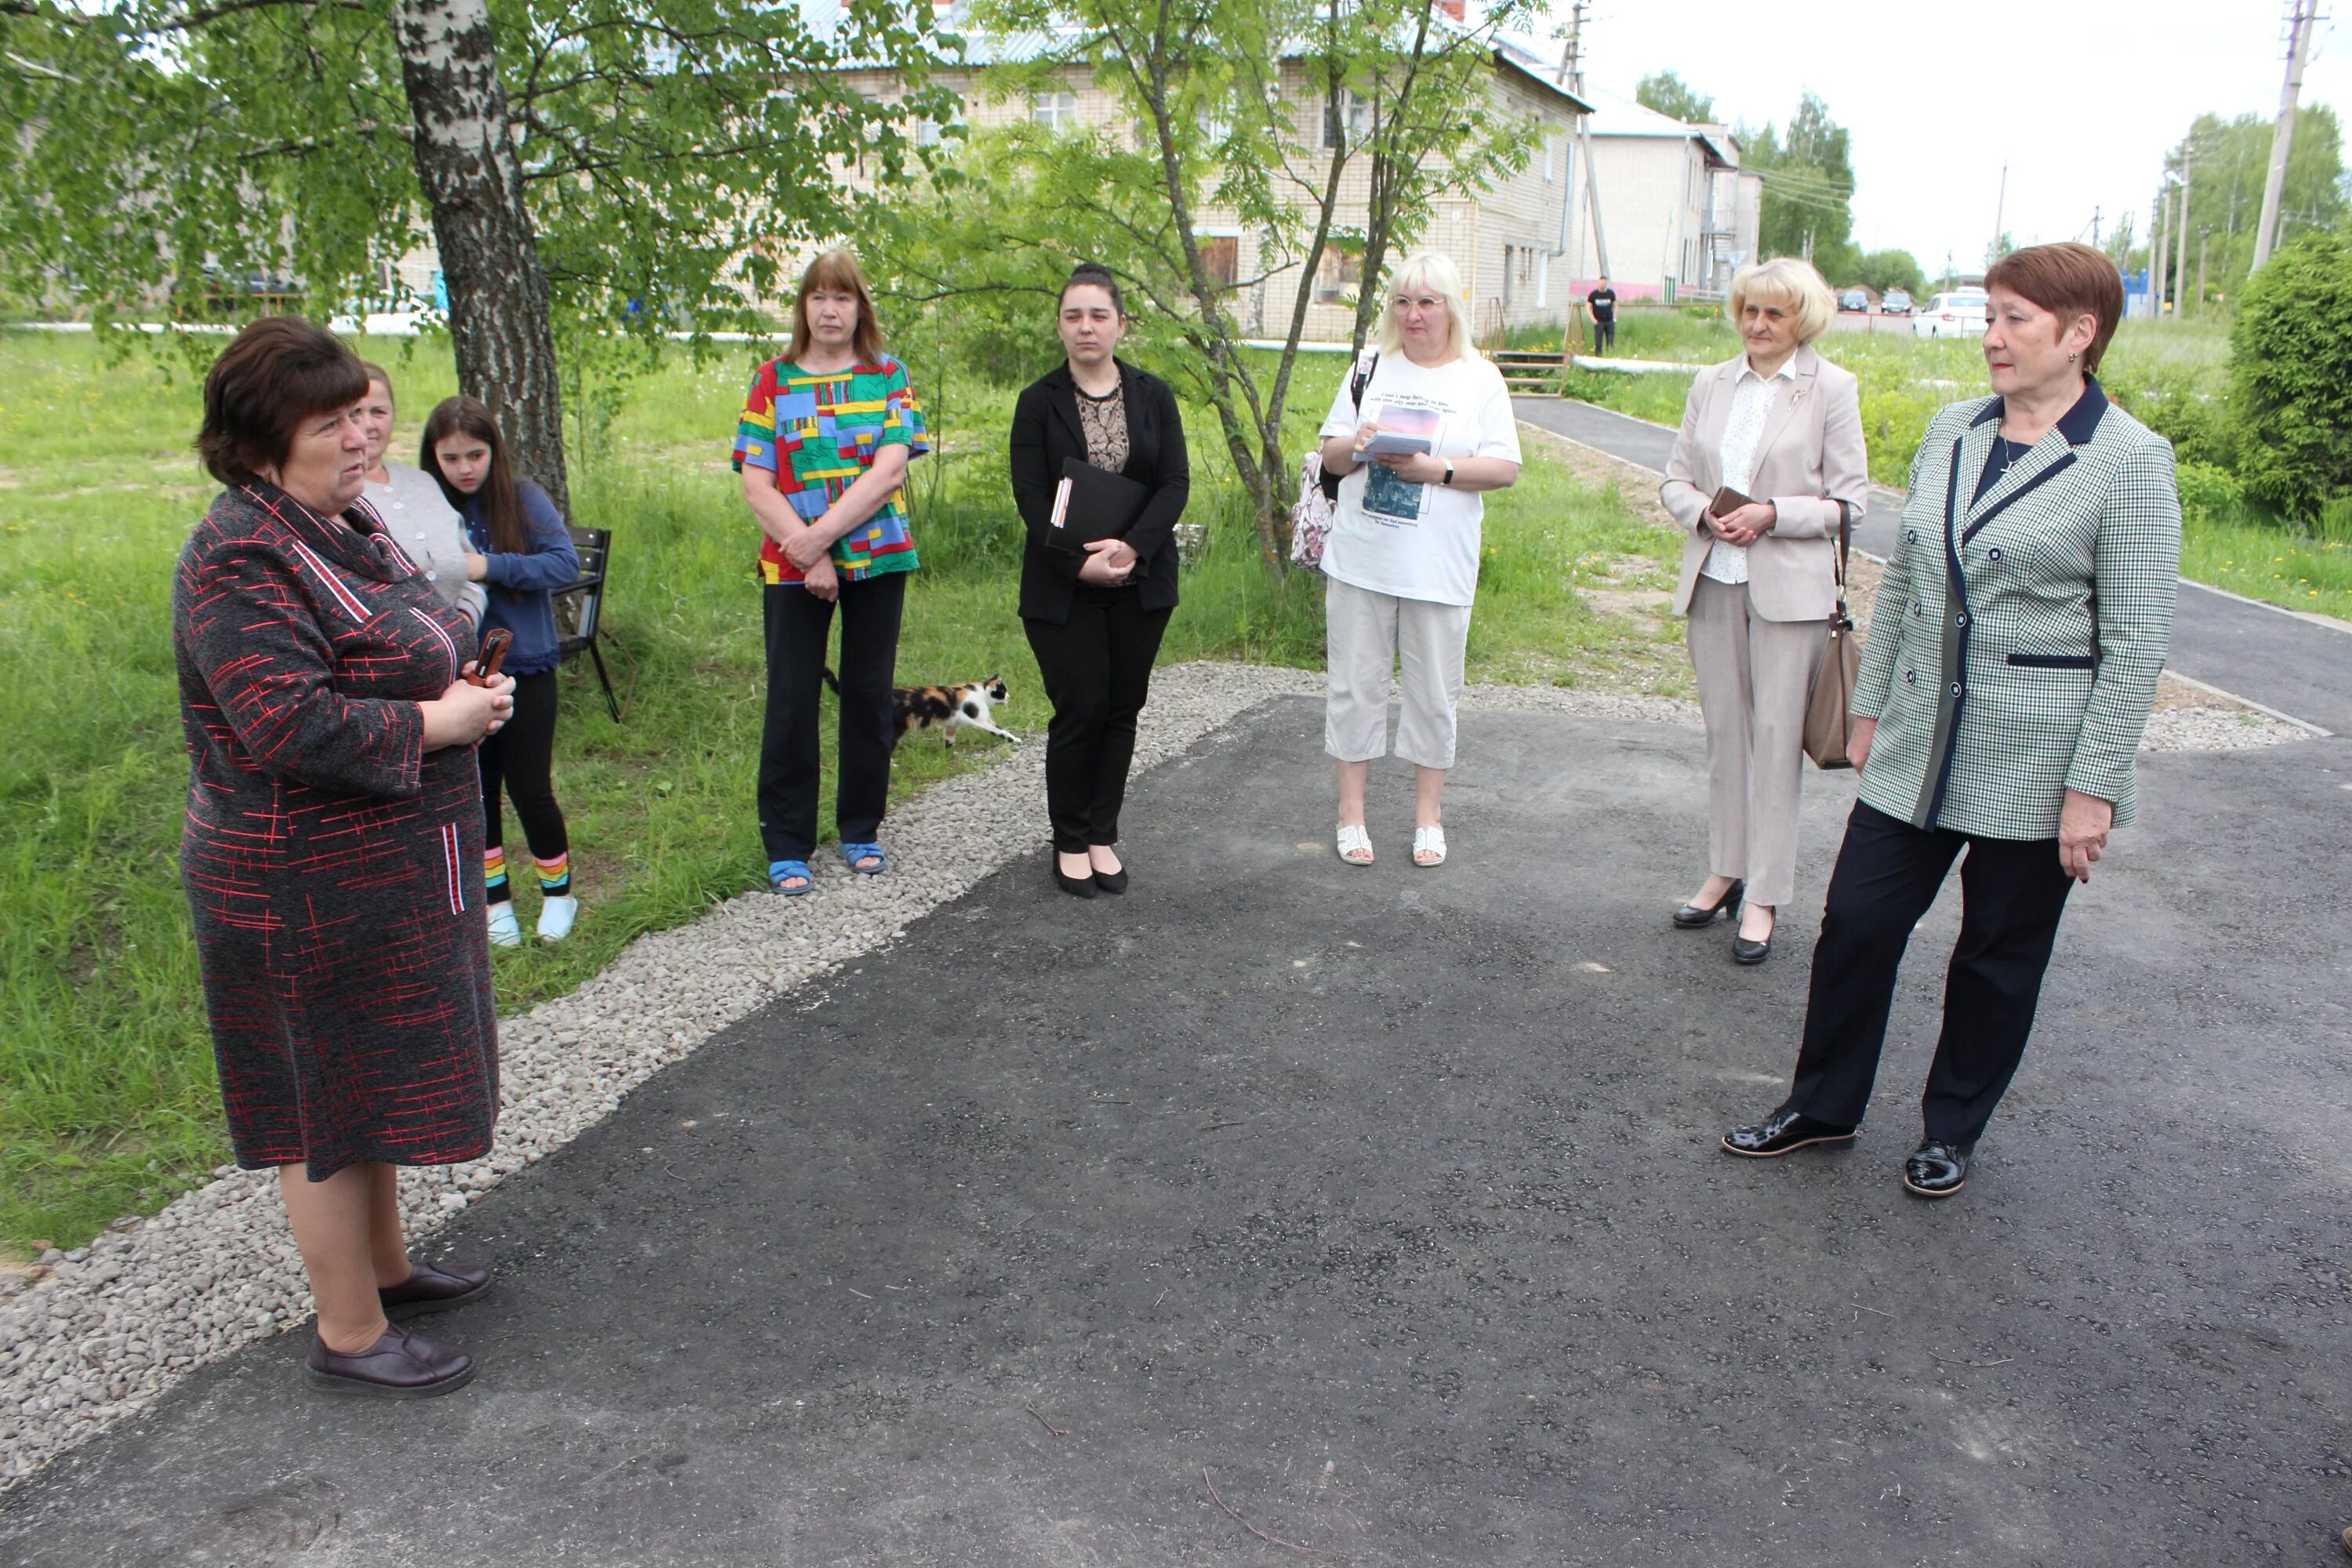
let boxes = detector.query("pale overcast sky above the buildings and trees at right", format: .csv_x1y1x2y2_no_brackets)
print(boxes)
1545,0,2352,282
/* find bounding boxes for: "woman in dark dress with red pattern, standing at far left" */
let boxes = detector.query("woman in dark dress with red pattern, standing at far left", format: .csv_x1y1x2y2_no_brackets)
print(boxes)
172,315,513,1394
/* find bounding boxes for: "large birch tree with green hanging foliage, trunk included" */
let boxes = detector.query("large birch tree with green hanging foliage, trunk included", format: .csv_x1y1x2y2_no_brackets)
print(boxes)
0,0,955,506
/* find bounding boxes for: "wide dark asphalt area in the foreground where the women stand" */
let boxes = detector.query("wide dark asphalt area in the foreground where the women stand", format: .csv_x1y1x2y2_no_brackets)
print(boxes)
0,699,2352,1568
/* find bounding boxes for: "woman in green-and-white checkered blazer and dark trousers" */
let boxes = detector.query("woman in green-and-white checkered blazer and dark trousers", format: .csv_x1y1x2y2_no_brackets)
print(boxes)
1724,245,2180,1196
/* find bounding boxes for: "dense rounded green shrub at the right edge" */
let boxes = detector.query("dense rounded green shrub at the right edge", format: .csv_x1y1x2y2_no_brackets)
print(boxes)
2230,233,2352,520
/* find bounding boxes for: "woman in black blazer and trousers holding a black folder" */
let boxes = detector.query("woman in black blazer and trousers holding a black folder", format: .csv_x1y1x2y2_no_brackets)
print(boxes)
1011,261,1192,898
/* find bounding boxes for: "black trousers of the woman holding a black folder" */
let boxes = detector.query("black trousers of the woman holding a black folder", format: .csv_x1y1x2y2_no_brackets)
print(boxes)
1021,583,1176,855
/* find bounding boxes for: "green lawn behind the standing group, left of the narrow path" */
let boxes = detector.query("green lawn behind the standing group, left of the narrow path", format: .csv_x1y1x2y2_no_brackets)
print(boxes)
0,332,1686,1253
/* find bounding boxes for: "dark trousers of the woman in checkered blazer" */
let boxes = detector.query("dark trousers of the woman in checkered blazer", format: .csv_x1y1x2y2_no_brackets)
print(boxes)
1788,801,2074,1142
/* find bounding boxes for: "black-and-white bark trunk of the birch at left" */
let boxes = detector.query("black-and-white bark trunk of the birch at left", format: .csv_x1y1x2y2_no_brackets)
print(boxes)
393,0,572,517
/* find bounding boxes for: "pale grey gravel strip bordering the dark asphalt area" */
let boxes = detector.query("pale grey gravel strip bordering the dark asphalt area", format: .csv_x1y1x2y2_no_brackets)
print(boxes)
0,663,2305,1490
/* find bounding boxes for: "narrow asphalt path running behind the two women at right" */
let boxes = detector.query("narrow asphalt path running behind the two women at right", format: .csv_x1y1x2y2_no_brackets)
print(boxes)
1512,397,2352,736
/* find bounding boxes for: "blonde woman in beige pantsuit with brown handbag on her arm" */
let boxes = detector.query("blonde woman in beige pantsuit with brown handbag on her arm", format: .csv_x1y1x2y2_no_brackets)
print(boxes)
1658,256,1870,964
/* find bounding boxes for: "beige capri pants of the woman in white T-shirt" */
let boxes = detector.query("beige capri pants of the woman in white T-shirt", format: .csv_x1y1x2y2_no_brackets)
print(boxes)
1324,579,1470,769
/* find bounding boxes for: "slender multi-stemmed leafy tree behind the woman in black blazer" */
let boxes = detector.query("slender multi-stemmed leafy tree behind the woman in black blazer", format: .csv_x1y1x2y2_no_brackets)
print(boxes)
866,0,1526,574
